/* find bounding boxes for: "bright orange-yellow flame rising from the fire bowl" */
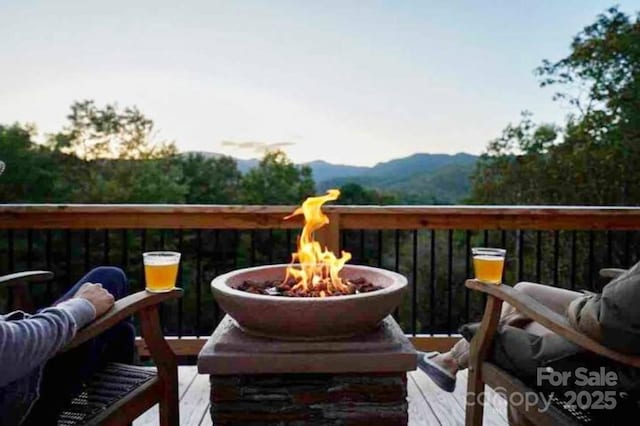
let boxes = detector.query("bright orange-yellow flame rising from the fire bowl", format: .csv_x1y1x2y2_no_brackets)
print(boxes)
285,189,351,297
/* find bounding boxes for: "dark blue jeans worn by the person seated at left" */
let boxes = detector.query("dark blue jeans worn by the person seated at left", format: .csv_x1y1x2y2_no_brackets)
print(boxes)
25,266,135,426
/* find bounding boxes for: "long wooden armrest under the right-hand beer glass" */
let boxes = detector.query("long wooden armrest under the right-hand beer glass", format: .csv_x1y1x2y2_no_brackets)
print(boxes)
465,280,640,367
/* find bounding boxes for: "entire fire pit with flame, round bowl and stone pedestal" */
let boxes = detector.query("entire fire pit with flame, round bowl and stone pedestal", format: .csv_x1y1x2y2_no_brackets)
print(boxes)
198,190,417,426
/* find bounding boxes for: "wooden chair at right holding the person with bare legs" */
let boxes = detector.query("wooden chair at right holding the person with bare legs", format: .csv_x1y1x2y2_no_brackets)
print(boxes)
465,269,640,426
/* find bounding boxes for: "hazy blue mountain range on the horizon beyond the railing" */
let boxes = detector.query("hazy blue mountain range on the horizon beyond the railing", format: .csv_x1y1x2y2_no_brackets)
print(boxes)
184,152,478,204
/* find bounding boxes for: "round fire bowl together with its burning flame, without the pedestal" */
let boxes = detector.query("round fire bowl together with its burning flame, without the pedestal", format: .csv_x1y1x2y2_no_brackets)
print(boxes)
211,189,407,340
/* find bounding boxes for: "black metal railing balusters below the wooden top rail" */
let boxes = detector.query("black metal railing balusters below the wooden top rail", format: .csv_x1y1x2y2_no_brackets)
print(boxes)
0,208,640,337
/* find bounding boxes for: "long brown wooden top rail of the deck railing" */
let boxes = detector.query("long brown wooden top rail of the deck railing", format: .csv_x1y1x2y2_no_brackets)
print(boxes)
0,204,640,232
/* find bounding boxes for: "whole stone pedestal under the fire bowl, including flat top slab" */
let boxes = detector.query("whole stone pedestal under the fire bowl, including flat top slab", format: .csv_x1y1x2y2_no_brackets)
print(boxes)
198,313,417,426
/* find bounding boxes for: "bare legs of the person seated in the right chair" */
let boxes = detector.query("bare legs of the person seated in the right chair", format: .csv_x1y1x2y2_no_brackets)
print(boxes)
422,283,582,388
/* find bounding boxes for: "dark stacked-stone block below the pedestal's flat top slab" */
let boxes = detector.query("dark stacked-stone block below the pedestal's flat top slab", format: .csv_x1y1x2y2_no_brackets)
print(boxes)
211,373,408,426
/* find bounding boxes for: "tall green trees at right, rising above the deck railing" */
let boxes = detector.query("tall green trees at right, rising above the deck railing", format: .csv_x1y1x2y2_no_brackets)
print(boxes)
472,8,640,205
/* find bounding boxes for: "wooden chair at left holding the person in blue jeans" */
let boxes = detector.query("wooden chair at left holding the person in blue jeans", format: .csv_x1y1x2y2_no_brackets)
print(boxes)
0,271,182,426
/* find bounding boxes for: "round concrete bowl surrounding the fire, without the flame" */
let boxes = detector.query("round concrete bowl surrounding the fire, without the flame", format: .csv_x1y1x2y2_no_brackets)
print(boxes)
211,265,407,340
